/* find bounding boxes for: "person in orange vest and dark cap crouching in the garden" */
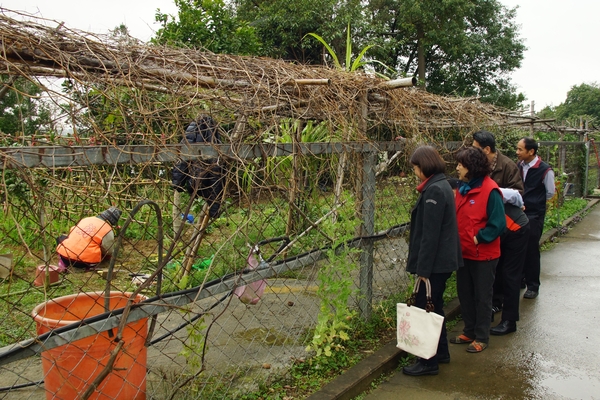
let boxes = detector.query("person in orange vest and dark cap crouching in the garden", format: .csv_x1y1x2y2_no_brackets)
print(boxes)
56,207,121,270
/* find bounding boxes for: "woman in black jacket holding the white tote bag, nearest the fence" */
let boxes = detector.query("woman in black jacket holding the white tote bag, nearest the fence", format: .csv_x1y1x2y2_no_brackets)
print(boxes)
402,146,462,376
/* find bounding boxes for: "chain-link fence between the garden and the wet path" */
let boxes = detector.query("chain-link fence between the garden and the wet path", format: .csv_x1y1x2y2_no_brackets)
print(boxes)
0,138,422,399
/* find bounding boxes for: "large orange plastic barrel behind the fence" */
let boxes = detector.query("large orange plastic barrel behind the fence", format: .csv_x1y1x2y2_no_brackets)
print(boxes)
32,292,148,400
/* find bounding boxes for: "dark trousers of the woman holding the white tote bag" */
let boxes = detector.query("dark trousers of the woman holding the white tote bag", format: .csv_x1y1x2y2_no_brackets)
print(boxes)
415,272,452,366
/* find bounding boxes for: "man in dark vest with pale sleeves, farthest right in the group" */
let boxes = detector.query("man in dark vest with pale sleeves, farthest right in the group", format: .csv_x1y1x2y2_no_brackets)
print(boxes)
517,138,555,299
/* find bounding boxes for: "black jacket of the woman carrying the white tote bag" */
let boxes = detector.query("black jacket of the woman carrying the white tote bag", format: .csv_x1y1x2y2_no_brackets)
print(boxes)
406,174,463,278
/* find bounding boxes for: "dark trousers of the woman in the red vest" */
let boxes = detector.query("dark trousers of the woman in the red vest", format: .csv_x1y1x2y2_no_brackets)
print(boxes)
456,258,498,343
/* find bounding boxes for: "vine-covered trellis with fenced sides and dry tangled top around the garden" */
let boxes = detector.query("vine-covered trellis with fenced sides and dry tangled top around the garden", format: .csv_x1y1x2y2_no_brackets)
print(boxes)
0,6,552,399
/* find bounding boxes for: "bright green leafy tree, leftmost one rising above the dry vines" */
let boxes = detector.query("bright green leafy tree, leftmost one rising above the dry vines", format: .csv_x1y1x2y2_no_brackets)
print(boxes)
152,0,262,55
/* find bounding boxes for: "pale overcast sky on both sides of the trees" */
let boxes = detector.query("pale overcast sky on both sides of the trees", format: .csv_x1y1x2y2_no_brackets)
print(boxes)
0,0,600,111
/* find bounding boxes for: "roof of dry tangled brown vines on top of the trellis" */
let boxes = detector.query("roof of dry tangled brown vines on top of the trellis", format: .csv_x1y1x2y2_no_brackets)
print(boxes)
0,9,506,141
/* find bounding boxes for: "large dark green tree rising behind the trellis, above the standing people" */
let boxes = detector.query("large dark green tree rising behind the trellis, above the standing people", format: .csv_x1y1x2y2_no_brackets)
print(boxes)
363,0,525,108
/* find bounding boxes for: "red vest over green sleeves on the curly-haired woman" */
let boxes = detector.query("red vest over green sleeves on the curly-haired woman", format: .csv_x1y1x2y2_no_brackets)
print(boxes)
456,176,500,261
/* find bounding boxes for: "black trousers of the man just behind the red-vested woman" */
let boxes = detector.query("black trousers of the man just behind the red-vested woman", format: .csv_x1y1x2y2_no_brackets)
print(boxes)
492,224,529,321
